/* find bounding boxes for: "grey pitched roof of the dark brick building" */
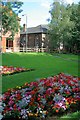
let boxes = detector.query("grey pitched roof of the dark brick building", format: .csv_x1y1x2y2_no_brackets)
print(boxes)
21,25,48,34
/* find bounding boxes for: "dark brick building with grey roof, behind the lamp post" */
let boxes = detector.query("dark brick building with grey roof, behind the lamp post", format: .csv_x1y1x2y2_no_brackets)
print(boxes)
20,25,48,52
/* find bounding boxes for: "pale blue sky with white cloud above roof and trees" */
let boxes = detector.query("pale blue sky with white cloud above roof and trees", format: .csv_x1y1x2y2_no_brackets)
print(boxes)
19,0,80,27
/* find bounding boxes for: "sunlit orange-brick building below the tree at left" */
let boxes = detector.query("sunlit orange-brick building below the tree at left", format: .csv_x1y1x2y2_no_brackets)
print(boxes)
1,32,20,52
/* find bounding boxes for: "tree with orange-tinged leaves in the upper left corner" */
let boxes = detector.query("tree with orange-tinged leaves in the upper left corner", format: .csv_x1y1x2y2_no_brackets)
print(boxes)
0,2,23,40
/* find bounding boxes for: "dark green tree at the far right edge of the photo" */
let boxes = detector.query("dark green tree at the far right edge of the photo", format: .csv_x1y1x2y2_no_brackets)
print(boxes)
71,2,80,53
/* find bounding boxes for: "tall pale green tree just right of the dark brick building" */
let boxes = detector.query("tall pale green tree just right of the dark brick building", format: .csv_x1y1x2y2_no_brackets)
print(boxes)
49,2,74,50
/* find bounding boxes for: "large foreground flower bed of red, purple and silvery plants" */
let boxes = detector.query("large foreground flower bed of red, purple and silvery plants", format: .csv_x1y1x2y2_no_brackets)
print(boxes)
2,73,80,120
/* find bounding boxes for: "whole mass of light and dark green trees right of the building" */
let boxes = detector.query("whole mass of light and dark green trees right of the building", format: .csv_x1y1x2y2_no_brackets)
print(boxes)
49,2,80,52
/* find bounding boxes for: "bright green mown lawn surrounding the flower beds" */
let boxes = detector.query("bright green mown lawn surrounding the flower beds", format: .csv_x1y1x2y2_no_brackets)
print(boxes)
2,53,80,92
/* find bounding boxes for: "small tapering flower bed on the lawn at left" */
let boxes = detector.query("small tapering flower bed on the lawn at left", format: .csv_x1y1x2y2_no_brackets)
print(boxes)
0,66,33,75
